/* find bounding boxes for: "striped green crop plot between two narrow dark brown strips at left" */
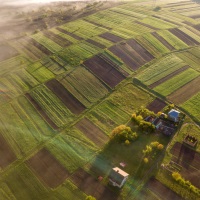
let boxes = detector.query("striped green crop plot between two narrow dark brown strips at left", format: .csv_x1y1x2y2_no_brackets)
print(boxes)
30,86,73,127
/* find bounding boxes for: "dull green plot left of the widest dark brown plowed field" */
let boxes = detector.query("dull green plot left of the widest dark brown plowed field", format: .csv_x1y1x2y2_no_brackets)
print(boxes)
58,67,109,107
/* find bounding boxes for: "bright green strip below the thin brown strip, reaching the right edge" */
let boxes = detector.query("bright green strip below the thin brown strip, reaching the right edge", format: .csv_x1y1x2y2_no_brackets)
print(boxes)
154,69,199,96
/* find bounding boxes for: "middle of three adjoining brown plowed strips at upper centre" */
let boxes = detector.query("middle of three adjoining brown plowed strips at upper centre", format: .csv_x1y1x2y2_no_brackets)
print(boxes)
120,43,146,66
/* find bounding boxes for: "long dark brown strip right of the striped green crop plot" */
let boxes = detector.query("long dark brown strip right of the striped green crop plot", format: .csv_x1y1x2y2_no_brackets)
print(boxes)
45,79,85,114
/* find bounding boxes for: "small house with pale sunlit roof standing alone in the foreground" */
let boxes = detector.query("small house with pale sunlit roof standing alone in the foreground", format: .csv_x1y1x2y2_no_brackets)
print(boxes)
108,167,129,188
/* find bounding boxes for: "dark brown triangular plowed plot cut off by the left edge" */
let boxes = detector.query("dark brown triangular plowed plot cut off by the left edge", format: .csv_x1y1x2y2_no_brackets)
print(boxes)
0,134,16,169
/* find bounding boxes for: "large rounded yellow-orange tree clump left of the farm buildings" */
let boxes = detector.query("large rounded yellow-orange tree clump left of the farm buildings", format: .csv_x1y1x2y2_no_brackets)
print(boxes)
111,125,138,143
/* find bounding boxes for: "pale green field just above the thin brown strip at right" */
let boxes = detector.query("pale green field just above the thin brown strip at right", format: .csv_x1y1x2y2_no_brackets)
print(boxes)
137,54,186,85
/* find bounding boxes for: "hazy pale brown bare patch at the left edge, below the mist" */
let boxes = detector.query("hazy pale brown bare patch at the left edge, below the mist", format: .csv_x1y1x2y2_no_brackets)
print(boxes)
0,44,19,62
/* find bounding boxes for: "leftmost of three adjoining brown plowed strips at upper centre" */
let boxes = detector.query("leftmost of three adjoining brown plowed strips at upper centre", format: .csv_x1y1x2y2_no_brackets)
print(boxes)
109,46,139,70
